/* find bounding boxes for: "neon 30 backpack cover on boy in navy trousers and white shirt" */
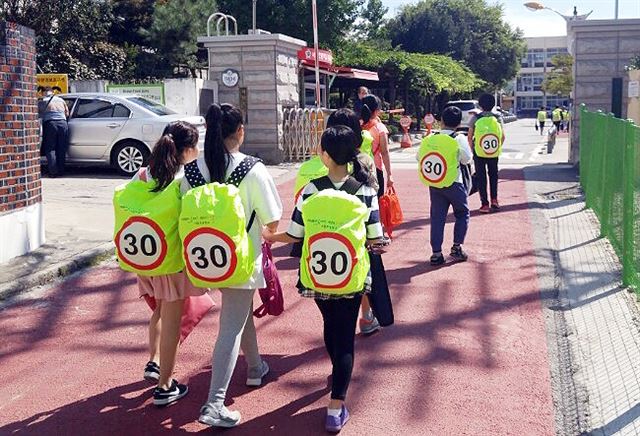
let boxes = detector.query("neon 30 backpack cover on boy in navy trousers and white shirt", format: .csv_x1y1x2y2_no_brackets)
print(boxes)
418,133,459,188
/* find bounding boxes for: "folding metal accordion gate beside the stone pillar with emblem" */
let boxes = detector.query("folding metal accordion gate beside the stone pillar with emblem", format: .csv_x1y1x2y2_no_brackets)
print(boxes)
282,108,328,162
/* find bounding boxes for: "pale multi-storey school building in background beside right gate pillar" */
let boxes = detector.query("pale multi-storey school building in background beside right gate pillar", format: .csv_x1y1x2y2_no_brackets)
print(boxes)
514,36,569,117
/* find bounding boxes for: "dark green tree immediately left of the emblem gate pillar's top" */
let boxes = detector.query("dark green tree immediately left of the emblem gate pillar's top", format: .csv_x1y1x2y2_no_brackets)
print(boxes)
142,0,216,77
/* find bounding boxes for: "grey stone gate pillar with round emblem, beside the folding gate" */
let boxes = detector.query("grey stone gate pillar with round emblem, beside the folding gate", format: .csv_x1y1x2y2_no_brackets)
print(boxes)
198,34,305,163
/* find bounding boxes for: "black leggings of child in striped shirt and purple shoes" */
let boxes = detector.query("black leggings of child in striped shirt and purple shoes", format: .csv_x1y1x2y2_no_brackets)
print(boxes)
315,295,362,401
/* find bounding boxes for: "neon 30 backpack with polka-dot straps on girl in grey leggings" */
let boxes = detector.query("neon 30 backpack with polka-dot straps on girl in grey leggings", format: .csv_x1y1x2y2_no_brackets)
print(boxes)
178,156,260,288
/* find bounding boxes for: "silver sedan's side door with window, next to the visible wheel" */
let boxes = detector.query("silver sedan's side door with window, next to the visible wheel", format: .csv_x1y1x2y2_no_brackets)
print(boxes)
68,98,131,161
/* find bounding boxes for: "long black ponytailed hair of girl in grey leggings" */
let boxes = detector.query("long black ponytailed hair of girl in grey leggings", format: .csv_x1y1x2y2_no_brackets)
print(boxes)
204,103,242,183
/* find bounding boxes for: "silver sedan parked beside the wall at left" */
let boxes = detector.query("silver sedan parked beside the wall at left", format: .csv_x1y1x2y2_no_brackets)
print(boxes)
54,93,205,176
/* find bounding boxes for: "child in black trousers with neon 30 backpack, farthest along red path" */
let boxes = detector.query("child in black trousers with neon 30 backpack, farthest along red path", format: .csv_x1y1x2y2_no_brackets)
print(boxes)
468,94,505,213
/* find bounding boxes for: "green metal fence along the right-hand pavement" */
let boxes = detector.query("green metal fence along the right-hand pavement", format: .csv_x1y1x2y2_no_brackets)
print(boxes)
580,105,640,290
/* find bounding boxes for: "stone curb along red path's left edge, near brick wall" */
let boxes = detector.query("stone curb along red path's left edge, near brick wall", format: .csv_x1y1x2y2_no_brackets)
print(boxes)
0,242,114,301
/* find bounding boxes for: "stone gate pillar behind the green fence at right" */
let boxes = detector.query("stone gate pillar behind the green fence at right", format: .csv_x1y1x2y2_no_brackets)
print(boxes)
568,19,640,164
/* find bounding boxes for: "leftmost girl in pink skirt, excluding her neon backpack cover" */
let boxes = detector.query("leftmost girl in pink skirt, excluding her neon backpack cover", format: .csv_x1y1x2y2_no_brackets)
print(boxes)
117,121,202,406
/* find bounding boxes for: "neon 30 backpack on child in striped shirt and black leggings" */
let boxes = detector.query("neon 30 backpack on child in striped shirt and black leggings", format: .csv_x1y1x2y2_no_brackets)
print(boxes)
300,177,370,295
